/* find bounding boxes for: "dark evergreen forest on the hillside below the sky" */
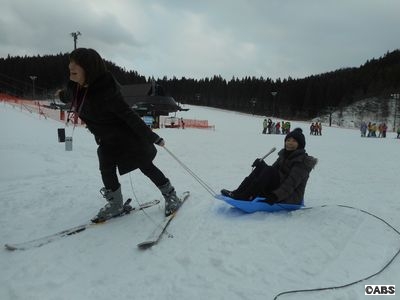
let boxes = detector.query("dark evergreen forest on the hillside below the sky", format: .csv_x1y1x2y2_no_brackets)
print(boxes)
0,50,400,119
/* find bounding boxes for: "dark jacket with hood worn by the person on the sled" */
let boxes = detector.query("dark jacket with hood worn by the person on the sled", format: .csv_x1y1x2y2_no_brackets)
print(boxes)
272,149,317,204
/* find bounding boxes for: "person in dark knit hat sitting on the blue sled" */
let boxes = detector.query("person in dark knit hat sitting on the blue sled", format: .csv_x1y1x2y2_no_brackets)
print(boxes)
221,128,317,205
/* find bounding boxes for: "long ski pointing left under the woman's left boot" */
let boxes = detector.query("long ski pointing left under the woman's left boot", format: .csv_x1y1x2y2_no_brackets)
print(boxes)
4,199,160,251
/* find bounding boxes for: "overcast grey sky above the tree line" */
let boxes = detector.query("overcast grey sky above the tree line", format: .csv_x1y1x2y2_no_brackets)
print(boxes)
0,0,400,80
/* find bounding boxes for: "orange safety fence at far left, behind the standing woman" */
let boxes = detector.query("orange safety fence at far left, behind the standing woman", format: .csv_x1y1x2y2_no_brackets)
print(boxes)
0,93,84,125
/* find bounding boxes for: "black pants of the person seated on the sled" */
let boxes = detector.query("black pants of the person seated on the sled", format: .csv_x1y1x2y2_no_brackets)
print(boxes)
235,162,280,199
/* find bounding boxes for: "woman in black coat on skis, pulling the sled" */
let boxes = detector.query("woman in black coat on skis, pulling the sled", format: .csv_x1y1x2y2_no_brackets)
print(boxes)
59,48,180,222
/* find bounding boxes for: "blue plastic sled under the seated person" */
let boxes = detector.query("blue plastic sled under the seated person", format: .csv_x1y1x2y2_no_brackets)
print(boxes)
215,195,304,213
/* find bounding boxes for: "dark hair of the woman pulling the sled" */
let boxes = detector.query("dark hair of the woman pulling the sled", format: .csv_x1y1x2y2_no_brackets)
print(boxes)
69,48,107,84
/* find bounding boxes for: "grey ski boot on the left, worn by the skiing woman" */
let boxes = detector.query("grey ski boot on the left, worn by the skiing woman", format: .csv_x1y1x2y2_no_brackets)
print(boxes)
92,186,123,223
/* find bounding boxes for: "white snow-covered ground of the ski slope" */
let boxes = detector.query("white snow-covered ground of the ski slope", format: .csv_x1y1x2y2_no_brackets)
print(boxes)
0,103,400,300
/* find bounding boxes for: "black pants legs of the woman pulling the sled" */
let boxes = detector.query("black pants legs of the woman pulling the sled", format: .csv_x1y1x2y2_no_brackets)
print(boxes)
99,159,168,191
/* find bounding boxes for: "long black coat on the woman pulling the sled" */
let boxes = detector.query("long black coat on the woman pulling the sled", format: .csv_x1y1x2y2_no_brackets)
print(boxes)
60,72,160,175
